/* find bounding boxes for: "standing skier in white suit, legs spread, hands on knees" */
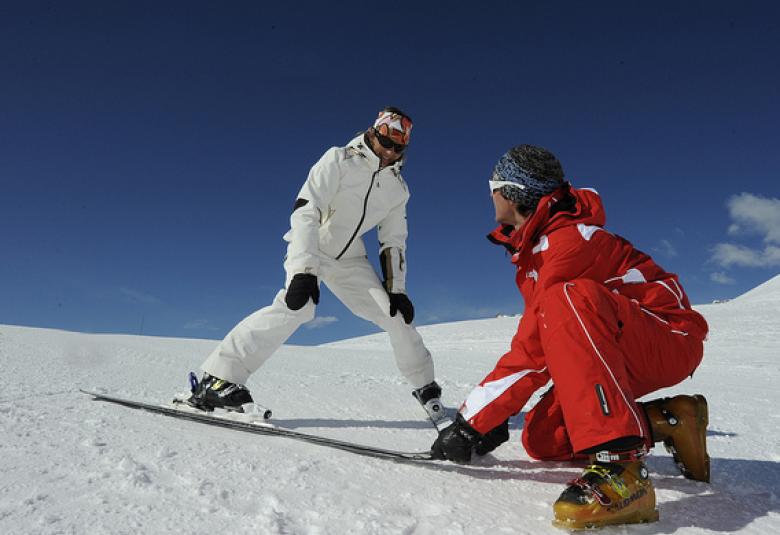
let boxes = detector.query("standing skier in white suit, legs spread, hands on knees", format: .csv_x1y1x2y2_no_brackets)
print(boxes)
190,108,441,412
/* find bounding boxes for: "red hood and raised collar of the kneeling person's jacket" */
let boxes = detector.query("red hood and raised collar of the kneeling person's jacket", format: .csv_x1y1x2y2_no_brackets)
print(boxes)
488,184,606,253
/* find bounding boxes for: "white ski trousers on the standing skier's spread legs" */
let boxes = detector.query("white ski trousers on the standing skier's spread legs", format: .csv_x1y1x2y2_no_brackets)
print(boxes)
201,257,434,389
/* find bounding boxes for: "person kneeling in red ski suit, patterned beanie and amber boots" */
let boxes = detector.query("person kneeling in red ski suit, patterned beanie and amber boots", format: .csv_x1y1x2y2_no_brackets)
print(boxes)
432,145,709,528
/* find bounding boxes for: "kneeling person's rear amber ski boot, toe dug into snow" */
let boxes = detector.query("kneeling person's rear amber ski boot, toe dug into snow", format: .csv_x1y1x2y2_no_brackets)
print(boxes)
642,395,710,483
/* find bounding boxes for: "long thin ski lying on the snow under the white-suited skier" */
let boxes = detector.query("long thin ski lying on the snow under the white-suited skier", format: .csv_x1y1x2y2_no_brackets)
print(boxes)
80,389,433,462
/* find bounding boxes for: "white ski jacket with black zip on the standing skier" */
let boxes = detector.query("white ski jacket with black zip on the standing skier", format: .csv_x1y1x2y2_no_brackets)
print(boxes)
284,134,409,293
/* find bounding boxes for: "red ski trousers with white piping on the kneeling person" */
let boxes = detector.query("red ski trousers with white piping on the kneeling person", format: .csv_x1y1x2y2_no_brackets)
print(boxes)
522,279,703,460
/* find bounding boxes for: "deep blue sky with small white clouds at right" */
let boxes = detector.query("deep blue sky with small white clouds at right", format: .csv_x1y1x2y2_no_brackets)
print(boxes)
0,1,780,344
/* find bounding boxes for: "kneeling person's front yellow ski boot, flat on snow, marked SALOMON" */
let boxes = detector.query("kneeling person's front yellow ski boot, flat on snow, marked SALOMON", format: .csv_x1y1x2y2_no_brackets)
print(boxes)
553,452,658,529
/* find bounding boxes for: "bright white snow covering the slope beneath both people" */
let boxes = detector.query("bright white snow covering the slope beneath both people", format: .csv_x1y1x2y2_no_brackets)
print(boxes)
0,276,780,535
